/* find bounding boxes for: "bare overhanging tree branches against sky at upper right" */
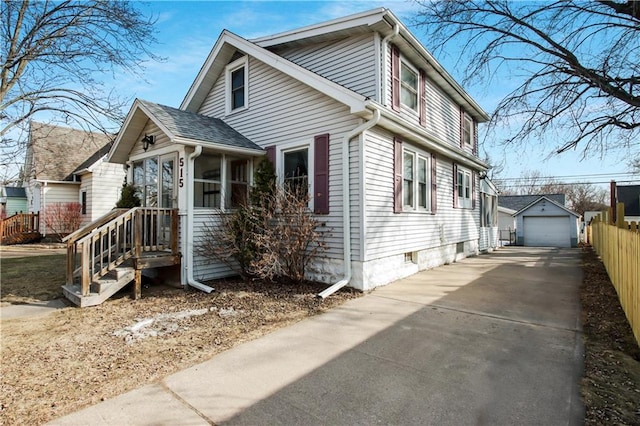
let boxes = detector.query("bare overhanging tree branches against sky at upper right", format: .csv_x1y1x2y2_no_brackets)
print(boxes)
415,0,640,159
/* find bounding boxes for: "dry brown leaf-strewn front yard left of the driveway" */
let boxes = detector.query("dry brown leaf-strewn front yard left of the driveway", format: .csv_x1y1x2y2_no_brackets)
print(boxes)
0,281,359,425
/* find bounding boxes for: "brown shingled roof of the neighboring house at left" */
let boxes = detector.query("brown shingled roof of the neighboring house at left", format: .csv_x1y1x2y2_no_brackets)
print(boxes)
25,121,111,181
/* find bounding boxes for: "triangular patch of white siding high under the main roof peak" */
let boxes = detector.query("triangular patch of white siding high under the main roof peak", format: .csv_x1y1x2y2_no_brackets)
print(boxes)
276,33,376,99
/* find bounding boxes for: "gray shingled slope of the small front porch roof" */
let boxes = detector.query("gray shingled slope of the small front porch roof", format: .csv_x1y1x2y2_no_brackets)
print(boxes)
140,100,262,150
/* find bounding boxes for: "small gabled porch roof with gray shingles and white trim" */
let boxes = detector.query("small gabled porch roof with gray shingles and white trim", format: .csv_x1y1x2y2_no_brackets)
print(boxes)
107,99,264,163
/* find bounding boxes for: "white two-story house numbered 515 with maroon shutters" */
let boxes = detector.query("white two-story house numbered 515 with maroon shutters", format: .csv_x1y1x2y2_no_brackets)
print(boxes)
108,8,495,290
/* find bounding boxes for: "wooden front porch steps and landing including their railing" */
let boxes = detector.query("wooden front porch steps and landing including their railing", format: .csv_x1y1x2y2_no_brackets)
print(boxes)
62,207,181,308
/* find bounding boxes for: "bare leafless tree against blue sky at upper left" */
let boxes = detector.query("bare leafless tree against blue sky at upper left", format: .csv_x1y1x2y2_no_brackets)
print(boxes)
0,0,159,181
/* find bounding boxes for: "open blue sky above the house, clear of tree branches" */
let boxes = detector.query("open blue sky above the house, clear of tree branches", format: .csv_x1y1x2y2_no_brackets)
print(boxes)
115,0,640,182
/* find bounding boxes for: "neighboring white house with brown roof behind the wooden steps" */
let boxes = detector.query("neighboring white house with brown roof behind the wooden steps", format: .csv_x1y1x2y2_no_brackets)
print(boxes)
24,122,125,235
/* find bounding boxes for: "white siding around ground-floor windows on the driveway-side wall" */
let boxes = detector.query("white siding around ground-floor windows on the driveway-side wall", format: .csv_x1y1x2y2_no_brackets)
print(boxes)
364,127,480,261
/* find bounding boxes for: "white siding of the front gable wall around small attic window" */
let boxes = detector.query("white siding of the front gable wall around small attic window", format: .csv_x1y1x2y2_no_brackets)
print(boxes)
198,57,361,259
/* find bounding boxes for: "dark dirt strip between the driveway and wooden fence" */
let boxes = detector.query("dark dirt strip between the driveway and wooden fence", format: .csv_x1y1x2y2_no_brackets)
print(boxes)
581,247,640,425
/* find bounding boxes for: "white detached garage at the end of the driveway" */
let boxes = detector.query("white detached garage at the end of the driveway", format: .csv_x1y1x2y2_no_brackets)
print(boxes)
514,196,580,247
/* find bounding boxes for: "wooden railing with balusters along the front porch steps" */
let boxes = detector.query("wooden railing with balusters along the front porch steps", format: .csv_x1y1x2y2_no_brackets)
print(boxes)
63,207,180,298
